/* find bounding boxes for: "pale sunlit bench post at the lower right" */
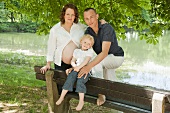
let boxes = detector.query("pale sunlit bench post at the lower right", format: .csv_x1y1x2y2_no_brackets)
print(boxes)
152,93,165,113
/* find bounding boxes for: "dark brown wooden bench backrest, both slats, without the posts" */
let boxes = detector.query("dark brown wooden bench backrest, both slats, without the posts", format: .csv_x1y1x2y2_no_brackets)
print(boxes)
34,66,170,112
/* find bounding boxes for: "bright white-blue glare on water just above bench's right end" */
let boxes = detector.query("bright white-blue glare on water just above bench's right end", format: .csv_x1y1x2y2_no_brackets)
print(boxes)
122,62,170,91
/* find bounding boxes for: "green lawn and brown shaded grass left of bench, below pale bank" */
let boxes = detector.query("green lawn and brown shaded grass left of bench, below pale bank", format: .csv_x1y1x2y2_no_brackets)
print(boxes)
0,63,47,113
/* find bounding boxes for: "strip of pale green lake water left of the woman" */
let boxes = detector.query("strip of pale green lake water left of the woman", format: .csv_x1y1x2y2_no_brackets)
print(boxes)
0,33,48,55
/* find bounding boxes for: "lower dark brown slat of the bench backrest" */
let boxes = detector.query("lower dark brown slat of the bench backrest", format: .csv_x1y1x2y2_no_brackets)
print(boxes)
52,78,151,110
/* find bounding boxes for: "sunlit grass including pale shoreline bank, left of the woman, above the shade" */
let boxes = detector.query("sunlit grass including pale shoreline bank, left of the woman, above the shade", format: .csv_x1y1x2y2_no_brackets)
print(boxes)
0,53,45,87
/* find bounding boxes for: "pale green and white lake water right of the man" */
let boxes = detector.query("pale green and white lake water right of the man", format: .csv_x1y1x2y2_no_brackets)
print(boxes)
117,32,170,90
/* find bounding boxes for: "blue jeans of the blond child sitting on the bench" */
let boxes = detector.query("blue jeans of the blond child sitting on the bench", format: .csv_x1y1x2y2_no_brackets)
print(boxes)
63,70,90,93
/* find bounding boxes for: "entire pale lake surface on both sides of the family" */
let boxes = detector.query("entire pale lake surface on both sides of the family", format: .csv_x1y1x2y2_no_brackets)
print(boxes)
0,32,170,91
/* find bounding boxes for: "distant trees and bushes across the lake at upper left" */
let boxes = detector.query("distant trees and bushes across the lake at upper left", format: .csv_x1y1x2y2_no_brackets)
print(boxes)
0,2,38,33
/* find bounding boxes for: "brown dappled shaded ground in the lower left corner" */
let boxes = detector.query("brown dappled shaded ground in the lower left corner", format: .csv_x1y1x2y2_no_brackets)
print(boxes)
0,85,47,113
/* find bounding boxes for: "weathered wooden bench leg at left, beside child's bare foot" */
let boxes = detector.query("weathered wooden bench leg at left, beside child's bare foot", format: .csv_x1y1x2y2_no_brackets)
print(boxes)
45,71,71,113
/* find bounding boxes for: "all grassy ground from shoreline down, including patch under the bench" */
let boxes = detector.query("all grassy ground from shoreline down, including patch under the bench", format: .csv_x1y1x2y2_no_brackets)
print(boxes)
0,52,117,113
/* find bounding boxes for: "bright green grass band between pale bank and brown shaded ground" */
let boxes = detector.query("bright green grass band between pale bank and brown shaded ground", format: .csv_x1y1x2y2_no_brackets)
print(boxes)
0,64,45,87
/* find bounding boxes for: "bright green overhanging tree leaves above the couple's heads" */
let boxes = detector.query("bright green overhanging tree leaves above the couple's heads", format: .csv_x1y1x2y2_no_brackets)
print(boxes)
0,0,170,44
